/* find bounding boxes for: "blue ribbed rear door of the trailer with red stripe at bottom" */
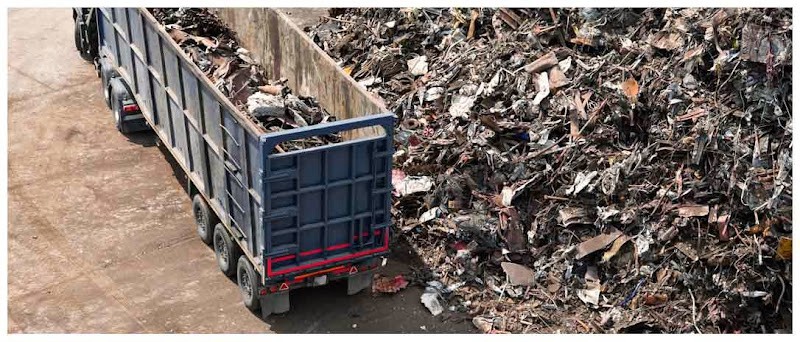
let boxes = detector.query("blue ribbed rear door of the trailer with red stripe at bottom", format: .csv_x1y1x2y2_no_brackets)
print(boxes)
261,114,393,278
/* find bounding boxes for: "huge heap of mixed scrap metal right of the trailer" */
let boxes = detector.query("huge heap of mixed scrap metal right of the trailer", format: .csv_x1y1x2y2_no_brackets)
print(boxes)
307,8,792,333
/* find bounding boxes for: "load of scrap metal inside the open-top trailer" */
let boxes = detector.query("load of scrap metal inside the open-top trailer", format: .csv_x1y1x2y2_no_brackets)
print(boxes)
150,8,341,152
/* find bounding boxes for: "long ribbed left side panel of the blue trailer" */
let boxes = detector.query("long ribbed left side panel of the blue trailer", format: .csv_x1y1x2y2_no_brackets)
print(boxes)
98,8,262,264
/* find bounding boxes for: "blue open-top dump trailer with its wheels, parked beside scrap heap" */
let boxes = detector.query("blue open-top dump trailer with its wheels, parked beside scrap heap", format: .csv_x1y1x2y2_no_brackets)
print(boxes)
73,8,394,317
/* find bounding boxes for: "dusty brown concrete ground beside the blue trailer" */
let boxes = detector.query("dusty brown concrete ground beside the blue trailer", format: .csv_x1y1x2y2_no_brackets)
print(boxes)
8,9,474,333
